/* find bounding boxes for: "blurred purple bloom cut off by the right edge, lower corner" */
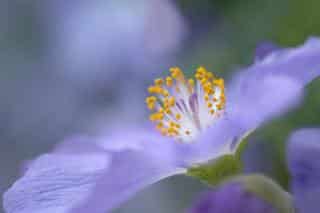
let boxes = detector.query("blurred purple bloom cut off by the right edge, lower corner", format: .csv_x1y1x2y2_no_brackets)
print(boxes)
287,129,320,213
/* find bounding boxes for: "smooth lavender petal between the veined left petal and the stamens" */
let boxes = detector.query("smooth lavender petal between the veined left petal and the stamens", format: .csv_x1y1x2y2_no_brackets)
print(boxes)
74,129,185,212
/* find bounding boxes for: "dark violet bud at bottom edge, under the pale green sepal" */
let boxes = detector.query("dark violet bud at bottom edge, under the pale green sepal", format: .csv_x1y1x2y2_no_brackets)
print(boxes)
188,182,277,213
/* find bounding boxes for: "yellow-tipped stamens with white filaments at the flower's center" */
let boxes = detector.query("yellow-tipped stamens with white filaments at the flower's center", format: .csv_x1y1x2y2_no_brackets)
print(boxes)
146,67,226,142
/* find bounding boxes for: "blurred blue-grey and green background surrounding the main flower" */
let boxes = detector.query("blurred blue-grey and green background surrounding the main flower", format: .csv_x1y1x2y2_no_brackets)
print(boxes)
0,0,320,213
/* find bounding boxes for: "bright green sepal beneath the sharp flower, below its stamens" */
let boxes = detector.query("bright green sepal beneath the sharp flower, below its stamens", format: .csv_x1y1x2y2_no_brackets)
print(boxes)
187,132,251,185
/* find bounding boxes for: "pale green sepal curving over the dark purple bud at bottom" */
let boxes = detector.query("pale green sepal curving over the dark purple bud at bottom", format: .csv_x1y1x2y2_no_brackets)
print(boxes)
230,174,295,213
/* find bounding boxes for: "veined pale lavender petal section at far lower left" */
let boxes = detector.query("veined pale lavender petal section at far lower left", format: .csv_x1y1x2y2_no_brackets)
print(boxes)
3,154,110,213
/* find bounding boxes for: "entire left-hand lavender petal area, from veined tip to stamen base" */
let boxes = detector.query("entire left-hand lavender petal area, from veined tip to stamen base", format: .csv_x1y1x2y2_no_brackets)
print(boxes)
4,131,182,213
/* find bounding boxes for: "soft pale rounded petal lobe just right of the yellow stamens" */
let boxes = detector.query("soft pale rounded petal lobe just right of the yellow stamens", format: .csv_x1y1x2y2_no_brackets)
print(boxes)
227,75,303,130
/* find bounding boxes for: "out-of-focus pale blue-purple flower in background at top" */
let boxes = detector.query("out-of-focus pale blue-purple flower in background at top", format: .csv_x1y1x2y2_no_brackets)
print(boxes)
39,0,185,89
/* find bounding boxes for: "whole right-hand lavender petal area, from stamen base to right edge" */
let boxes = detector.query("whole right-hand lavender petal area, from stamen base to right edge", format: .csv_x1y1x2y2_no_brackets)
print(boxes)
195,39,320,162
